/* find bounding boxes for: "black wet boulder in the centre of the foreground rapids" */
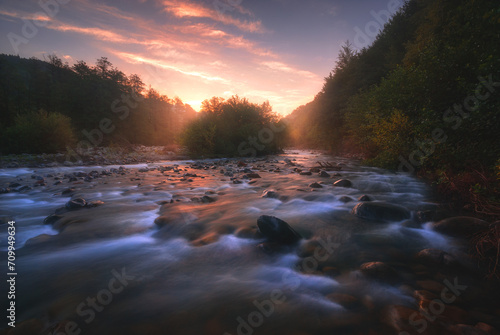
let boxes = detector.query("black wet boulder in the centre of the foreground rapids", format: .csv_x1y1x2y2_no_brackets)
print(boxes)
257,215,302,244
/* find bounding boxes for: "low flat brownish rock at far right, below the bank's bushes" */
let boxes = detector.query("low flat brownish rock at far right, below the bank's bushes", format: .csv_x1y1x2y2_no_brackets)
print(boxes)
432,216,489,238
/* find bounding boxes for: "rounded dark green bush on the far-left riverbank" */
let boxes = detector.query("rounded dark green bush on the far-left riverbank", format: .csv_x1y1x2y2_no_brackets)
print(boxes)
1,110,75,153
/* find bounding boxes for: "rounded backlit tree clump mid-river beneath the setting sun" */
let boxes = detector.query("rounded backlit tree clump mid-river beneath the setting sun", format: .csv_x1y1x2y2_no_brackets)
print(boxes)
182,96,285,157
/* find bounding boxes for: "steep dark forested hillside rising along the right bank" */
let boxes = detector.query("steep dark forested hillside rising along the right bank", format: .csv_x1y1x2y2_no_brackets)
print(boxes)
288,0,500,213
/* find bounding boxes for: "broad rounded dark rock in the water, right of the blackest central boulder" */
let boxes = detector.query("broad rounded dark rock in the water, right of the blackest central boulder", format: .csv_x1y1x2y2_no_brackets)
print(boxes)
352,202,411,222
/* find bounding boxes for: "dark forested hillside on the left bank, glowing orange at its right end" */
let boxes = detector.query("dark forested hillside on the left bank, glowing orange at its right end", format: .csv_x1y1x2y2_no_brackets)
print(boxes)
0,55,196,154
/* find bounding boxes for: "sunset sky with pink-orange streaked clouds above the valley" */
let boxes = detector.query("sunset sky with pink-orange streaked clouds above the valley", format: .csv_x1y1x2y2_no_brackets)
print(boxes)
0,0,401,115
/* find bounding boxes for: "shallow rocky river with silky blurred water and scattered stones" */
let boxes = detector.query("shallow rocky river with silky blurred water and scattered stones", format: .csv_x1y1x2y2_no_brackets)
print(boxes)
0,151,500,335
